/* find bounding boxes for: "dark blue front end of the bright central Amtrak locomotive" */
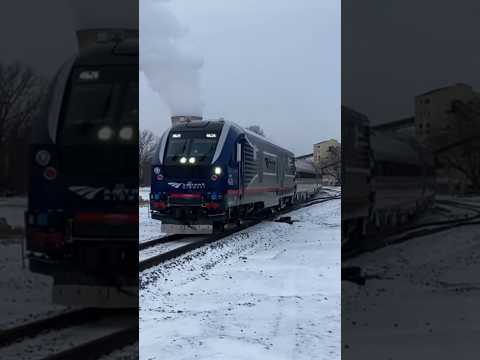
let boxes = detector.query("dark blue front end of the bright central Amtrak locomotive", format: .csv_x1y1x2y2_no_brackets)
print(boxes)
150,121,232,234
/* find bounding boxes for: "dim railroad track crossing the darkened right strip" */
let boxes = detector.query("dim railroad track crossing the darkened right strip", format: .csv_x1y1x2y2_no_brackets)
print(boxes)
342,200,480,260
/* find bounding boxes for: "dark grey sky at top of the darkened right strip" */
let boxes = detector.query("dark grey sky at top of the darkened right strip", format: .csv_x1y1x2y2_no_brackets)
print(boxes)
342,0,480,123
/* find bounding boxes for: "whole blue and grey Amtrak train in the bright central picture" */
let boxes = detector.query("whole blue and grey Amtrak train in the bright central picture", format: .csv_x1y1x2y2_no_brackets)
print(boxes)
150,117,320,234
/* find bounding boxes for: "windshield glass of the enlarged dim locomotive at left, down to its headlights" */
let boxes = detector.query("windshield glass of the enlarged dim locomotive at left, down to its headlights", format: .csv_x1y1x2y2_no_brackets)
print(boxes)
58,67,138,145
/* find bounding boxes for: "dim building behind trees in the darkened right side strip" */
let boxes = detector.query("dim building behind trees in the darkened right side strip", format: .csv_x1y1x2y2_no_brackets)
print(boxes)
415,83,480,193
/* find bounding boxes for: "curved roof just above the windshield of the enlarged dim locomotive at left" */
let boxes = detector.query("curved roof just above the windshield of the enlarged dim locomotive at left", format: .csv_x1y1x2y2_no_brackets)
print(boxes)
75,39,139,66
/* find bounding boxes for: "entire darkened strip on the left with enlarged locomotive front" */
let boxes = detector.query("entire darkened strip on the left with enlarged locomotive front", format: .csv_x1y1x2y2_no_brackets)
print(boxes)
0,0,138,358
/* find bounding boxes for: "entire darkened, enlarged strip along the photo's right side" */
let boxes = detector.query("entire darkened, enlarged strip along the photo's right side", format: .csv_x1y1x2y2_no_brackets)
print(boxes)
342,0,480,359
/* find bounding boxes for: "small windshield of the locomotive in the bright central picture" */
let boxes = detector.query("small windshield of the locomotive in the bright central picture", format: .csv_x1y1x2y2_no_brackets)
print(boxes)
165,131,218,165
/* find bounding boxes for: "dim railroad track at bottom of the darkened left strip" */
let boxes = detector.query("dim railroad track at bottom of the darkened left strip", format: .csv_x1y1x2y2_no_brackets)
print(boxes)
0,309,138,360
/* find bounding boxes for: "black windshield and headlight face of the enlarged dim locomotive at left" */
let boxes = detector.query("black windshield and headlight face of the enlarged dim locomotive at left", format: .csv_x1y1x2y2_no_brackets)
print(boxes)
57,66,138,177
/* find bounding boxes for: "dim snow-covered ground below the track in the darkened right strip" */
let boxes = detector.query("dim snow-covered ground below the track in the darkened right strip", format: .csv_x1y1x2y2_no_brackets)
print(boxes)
342,198,480,359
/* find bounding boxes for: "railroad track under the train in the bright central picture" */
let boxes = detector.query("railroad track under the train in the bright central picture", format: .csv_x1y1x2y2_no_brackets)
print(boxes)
139,194,341,272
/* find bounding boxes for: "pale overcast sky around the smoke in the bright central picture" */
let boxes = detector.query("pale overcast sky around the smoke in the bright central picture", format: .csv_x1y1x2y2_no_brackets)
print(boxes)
140,0,340,155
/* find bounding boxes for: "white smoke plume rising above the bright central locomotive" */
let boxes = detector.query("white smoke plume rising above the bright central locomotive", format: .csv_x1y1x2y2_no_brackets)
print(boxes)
140,0,203,116
